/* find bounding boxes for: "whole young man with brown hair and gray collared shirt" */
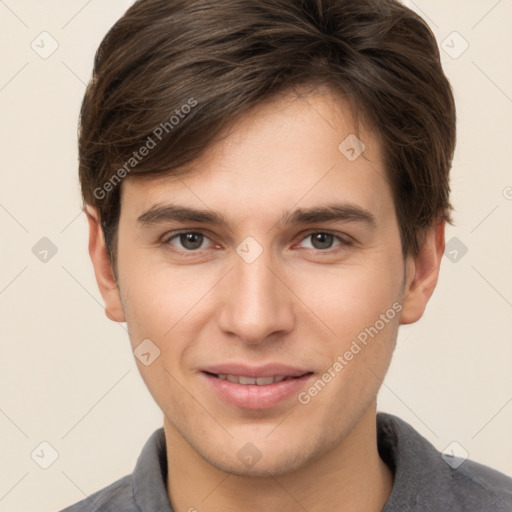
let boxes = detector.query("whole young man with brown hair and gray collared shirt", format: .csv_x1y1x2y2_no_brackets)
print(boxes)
62,0,512,512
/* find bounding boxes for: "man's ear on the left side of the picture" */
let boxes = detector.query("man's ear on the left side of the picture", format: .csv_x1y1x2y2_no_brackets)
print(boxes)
85,205,125,322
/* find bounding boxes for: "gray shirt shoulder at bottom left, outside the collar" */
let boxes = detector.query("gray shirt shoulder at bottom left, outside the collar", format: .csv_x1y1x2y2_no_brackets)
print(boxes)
57,475,139,512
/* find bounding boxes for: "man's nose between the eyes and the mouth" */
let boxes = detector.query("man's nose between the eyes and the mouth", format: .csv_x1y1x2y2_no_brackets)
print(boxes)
218,247,294,344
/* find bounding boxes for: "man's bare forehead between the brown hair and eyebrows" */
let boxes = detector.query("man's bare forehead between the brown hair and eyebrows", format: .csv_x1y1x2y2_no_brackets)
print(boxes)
121,90,393,226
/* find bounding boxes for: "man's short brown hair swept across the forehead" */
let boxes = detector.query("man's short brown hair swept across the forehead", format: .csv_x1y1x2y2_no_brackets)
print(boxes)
79,0,456,269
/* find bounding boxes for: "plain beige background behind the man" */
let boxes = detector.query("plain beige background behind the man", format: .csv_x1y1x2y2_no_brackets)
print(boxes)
0,0,512,512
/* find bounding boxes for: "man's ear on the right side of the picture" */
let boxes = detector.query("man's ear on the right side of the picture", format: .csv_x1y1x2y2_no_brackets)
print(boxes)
400,221,446,324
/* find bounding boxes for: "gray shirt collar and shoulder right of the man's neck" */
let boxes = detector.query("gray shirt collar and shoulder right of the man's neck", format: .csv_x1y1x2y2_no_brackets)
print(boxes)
377,413,512,512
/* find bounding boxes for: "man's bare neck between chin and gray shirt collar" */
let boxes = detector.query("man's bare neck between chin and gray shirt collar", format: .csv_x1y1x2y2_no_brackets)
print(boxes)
164,403,393,512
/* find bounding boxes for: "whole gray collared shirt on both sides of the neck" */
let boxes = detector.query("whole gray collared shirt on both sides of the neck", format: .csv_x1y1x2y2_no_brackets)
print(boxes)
61,413,512,512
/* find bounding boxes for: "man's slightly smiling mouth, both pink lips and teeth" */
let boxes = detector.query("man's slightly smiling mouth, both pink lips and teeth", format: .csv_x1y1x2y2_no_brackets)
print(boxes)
200,365,314,410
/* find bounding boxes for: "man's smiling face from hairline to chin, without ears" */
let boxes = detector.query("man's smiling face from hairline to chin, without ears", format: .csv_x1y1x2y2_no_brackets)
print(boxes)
112,88,404,475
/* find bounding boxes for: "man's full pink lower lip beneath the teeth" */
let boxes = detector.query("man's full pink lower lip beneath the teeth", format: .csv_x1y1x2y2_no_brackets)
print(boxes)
202,372,313,410
